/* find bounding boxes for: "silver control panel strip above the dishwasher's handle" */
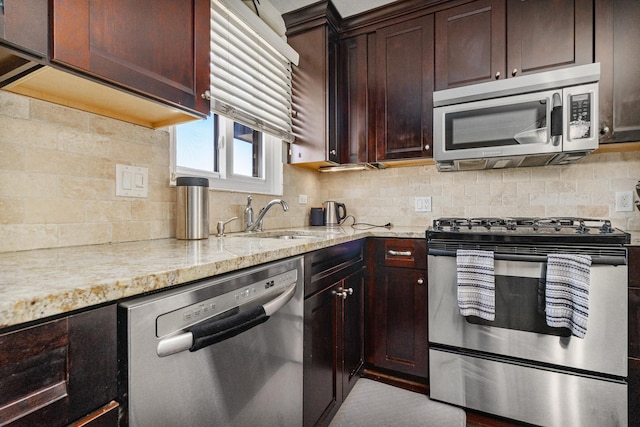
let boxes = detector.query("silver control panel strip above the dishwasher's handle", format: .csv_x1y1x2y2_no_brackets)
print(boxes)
156,270,298,337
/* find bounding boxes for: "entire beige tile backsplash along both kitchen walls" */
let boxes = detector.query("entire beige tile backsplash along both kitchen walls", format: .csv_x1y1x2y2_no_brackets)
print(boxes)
0,91,640,252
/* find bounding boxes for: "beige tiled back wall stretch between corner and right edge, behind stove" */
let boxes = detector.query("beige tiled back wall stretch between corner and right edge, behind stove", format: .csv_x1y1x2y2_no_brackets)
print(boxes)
320,151,640,234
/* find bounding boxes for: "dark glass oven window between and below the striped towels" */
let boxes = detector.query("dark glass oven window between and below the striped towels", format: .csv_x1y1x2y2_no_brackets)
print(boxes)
466,275,571,337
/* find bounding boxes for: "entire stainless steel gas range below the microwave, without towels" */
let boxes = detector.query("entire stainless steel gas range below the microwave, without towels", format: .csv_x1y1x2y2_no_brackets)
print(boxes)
426,218,629,427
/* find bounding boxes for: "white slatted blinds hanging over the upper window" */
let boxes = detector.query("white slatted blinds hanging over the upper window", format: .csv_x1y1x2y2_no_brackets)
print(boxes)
210,0,297,142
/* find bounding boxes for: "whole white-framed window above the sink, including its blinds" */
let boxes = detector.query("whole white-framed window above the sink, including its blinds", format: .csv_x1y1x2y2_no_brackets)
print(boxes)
171,0,299,195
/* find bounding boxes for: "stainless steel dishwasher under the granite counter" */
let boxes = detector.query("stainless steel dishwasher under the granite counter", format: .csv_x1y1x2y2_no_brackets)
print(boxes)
118,257,304,427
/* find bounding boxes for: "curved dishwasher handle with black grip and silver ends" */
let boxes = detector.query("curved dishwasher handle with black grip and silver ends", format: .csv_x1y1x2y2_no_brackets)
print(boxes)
156,283,296,357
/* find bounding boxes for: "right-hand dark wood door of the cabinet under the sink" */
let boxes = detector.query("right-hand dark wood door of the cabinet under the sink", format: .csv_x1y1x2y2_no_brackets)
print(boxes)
341,270,364,400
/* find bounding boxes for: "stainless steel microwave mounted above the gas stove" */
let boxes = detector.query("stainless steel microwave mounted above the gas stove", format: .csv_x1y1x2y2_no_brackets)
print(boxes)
433,63,600,171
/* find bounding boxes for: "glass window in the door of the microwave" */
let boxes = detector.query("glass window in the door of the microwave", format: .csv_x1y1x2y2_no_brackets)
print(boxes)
445,99,550,150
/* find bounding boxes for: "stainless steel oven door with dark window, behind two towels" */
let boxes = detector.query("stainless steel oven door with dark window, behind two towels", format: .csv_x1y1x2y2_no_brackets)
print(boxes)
428,250,627,377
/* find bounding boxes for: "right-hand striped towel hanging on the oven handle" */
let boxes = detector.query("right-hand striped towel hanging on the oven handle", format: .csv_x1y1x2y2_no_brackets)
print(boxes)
545,254,591,338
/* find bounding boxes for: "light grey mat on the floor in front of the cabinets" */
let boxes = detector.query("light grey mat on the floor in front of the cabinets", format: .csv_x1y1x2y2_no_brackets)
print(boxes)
329,378,466,427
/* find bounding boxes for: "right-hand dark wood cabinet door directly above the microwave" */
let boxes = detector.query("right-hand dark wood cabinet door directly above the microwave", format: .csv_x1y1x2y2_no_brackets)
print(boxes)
507,0,593,77
